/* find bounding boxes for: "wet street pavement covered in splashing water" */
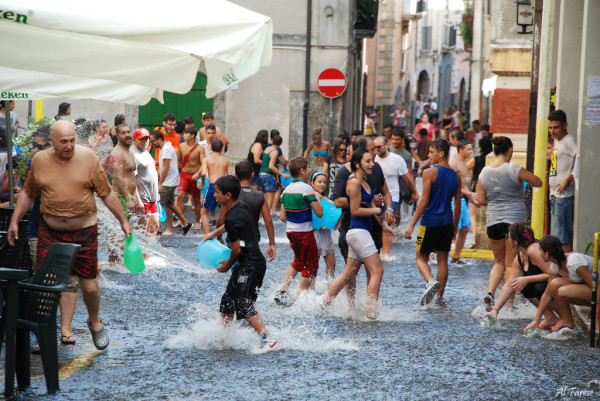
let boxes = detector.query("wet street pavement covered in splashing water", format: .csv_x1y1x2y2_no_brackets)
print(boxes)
4,203,600,400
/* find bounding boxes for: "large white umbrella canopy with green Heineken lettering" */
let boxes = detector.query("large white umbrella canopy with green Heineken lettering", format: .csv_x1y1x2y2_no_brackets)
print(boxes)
0,0,273,104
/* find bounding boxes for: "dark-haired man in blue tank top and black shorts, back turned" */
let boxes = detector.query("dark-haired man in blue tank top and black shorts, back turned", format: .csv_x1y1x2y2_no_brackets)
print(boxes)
404,139,461,306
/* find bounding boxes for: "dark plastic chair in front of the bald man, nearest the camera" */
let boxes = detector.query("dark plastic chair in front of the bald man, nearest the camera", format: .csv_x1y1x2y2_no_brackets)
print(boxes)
8,243,80,394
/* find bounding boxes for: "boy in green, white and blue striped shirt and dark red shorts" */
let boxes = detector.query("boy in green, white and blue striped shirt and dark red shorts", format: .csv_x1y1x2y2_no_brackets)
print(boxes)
274,157,323,305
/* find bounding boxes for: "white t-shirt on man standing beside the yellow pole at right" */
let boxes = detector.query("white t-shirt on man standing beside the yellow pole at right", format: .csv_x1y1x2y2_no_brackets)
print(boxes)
548,134,577,198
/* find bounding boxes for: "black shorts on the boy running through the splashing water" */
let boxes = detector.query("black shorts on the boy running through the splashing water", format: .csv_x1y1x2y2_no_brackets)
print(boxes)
219,263,266,319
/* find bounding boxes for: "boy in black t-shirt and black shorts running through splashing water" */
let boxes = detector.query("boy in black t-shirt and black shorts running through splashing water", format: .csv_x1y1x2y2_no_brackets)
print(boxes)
209,176,277,353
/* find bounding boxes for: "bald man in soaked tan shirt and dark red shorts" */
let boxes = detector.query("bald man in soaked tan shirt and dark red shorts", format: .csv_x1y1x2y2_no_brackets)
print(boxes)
8,120,131,349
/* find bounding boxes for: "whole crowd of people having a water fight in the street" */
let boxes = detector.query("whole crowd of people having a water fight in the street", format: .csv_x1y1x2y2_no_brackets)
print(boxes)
4,99,600,351
